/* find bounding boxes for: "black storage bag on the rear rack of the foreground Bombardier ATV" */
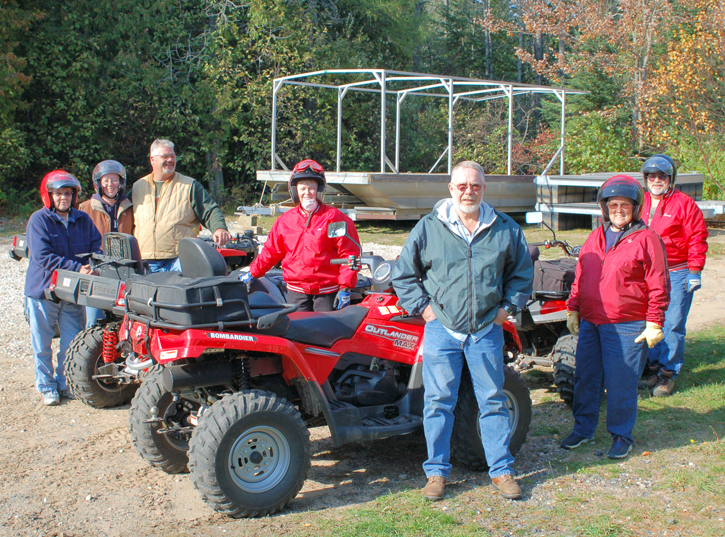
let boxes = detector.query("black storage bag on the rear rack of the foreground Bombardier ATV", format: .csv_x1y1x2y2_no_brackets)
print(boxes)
127,272,249,326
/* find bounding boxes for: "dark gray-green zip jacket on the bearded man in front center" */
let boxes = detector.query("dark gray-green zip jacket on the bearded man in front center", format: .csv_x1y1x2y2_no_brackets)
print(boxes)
393,200,533,334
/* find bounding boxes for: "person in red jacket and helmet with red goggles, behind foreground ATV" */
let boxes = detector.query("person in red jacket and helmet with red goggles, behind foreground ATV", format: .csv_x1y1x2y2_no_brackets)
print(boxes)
240,159,360,311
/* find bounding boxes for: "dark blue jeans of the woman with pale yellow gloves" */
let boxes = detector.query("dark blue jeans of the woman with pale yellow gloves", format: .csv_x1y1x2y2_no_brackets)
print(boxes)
572,320,647,444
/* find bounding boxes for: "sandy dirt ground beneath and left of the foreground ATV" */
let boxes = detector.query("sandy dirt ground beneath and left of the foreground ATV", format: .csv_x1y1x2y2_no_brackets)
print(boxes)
0,239,725,536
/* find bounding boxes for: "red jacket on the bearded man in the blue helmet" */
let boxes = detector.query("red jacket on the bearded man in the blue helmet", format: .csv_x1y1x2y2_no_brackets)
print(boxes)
642,189,708,271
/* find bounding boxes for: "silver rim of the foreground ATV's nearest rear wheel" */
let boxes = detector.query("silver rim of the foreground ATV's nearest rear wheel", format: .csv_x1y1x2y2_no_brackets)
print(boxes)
228,426,292,494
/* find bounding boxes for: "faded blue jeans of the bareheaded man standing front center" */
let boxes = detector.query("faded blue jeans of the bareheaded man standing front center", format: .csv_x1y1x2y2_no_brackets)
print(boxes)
423,320,514,478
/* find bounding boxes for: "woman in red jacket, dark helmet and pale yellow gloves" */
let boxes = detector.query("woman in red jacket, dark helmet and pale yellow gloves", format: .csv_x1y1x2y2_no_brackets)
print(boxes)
561,175,670,459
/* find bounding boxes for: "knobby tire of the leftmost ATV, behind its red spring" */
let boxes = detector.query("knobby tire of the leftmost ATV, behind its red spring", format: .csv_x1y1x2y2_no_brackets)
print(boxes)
65,326,138,408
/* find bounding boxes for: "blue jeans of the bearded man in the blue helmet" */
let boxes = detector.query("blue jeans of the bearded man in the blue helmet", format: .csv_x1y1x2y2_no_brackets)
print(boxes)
649,269,694,378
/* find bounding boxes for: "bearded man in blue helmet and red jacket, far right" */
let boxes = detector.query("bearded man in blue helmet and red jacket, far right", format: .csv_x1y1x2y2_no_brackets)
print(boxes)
642,155,708,397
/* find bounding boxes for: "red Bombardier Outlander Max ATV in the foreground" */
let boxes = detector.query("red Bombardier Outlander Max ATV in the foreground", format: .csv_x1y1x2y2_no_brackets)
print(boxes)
120,222,531,518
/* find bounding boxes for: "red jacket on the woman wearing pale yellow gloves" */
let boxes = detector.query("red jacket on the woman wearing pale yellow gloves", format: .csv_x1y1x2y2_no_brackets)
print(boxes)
566,221,670,326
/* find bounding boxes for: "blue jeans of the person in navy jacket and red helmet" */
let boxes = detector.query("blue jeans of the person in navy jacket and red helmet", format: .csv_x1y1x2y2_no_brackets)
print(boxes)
25,297,85,393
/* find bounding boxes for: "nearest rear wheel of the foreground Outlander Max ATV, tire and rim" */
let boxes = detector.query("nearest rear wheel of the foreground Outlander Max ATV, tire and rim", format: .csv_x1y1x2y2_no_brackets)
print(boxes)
189,390,311,518
